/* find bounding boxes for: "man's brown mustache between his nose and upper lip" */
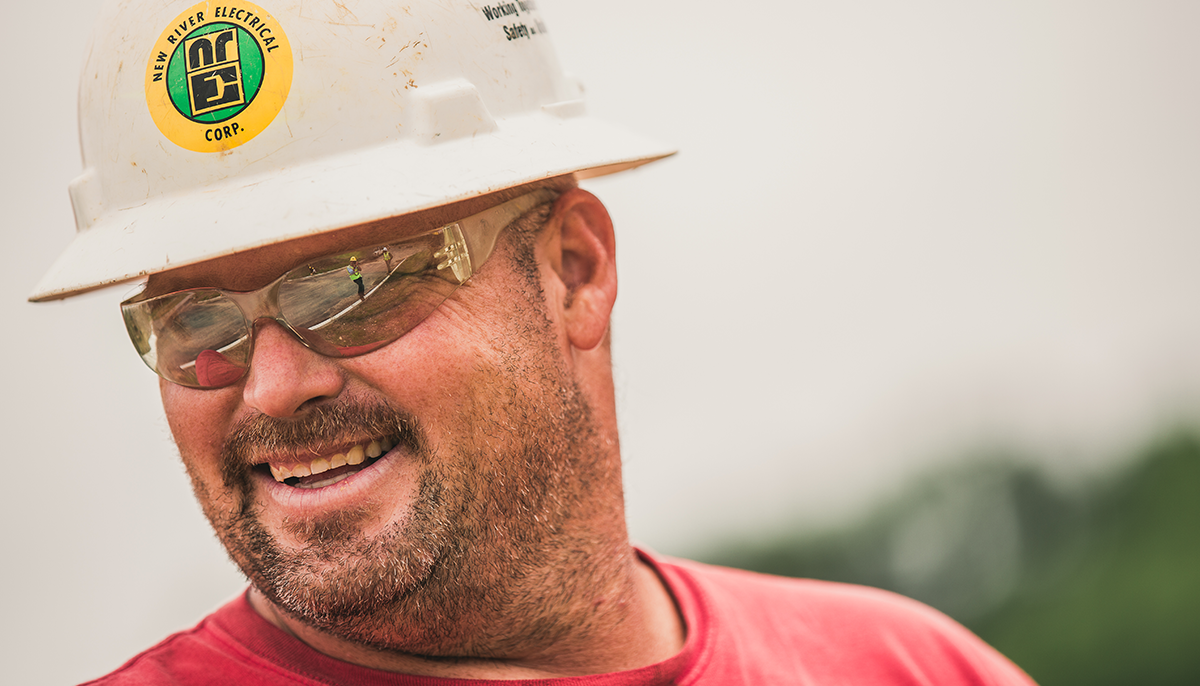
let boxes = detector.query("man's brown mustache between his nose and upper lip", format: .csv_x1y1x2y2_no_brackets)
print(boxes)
221,401,426,495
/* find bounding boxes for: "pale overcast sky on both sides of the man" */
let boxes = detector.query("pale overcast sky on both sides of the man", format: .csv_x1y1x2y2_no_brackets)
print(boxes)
0,0,1200,685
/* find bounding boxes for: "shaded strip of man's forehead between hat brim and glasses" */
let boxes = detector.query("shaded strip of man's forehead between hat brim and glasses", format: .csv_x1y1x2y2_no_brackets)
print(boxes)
145,189,530,295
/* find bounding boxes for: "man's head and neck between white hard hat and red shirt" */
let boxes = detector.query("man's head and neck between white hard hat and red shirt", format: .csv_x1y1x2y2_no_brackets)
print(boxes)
139,181,683,678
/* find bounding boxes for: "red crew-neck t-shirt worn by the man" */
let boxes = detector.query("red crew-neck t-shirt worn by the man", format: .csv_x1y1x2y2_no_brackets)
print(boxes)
91,553,1033,686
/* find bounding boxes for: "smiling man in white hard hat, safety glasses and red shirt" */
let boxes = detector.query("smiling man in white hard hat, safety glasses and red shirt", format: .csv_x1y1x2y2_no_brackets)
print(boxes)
34,0,1028,685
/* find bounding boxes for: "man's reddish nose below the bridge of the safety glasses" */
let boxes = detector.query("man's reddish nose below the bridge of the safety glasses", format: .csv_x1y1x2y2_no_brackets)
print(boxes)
242,319,346,417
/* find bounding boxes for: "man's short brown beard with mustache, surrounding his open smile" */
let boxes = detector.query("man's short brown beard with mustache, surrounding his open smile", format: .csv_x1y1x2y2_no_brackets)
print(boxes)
185,302,609,657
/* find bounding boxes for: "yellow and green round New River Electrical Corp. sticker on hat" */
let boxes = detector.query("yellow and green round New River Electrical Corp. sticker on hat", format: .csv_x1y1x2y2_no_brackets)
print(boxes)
146,0,292,152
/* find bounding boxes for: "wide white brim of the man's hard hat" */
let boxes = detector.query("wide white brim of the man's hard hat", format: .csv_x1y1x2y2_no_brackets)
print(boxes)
29,113,674,302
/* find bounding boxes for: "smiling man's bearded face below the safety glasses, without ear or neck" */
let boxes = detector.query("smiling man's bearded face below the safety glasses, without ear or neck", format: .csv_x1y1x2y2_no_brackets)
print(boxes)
162,207,600,655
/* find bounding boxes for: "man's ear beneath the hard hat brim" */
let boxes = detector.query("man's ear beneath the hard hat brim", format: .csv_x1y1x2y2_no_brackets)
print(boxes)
547,188,617,350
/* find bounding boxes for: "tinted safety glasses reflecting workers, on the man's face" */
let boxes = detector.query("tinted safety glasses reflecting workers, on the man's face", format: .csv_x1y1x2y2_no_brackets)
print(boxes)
121,188,556,389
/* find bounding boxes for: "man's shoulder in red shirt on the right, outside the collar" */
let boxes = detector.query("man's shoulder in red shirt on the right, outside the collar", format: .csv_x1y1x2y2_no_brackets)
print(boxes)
656,558,1032,685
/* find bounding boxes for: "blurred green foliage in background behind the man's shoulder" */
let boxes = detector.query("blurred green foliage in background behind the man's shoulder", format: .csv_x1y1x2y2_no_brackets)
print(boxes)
701,432,1200,686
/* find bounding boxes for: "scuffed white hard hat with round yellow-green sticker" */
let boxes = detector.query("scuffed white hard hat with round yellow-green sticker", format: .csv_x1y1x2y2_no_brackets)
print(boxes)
30,0,672,301
